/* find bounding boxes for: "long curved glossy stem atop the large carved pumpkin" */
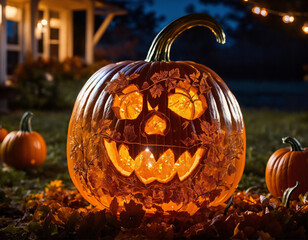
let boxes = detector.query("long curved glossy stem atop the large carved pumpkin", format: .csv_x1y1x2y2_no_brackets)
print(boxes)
145,13,226,62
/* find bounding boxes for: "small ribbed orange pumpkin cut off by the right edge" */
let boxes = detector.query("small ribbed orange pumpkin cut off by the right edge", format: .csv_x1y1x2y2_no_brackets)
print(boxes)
265,137,308,198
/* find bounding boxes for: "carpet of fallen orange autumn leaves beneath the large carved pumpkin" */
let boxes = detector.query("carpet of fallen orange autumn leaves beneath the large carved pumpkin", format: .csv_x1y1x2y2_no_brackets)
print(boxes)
0,180,308,239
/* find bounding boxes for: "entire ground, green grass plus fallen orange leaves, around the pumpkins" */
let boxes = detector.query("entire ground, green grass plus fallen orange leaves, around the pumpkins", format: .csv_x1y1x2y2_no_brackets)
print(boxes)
0,109,308,239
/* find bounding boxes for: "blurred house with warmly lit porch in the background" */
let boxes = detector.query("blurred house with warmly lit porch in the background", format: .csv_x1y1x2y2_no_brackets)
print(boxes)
0,0,126,85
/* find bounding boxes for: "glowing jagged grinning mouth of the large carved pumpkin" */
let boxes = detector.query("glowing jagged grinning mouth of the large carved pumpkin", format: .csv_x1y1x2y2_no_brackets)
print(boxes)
104,139,205,184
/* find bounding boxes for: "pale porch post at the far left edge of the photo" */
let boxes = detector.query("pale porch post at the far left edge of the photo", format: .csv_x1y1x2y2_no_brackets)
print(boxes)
0,0,7,85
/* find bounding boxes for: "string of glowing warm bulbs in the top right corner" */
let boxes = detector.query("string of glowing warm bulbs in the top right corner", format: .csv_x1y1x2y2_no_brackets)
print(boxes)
243,0,308,34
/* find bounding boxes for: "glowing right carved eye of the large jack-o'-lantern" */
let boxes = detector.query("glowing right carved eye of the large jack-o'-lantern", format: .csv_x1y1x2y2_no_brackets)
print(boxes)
168,82,207,120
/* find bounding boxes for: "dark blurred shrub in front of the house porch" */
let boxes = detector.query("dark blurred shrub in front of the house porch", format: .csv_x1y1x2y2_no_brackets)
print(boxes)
10,57,108,109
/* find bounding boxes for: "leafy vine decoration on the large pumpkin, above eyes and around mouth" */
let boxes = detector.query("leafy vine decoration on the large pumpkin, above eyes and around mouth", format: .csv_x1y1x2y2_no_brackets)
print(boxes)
70,68,244,218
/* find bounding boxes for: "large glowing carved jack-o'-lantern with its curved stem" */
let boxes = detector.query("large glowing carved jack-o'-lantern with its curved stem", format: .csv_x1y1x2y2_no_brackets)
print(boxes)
67,14,246,214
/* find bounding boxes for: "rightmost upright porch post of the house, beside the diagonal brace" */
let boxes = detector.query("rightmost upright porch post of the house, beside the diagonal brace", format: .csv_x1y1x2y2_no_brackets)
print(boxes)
85,0,94,64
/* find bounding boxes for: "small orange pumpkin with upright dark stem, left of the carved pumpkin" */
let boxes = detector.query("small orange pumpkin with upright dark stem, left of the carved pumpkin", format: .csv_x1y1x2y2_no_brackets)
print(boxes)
1,112,47,169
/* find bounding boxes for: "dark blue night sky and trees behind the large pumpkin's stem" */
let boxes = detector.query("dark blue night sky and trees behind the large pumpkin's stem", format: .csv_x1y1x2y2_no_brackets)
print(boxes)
74,0,308,110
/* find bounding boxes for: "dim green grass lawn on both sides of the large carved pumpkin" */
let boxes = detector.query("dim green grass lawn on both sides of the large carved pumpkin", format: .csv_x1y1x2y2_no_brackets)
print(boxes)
0,109,308,193
